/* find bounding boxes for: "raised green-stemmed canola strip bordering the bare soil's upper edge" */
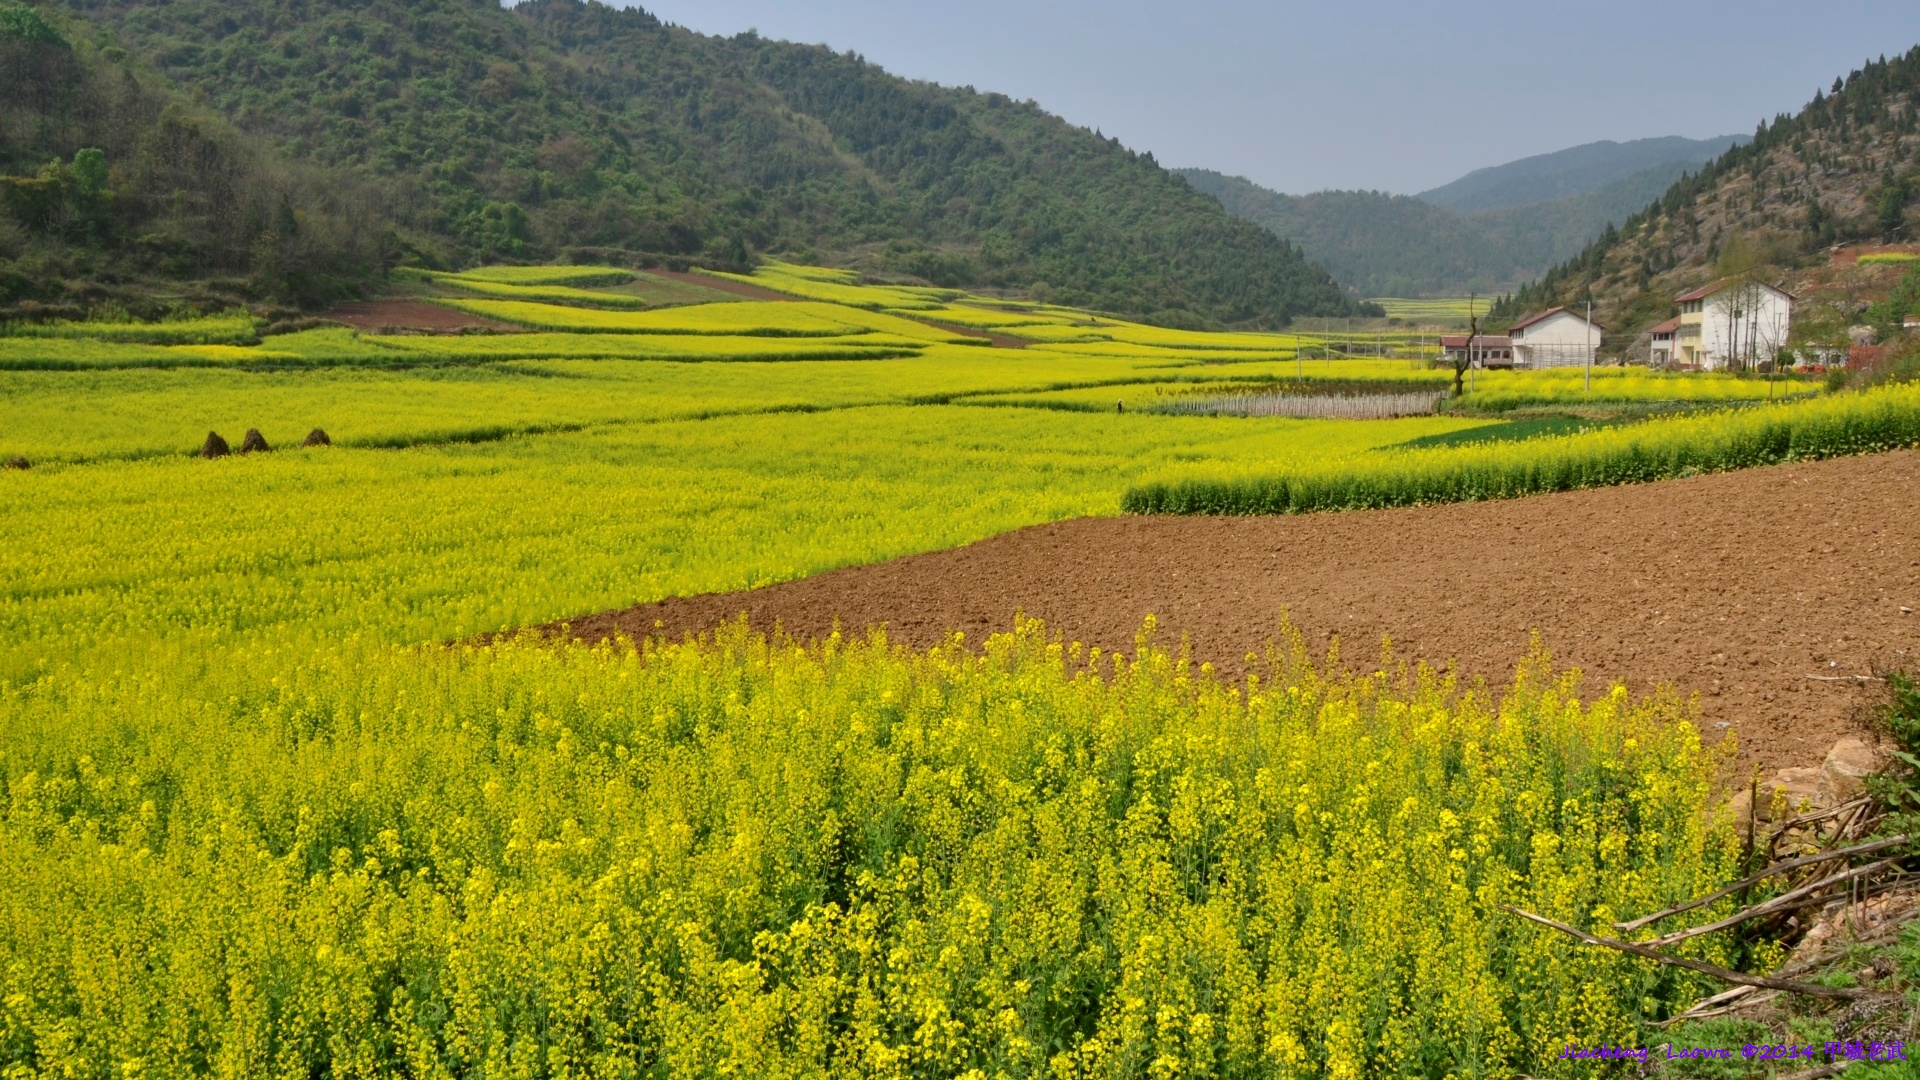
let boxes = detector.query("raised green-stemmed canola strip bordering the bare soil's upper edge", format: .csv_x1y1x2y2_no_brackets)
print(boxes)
1123,384,1920,513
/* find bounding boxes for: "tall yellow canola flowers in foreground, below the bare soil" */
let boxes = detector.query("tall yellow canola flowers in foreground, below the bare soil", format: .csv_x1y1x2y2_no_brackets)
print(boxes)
0,623,1738,1078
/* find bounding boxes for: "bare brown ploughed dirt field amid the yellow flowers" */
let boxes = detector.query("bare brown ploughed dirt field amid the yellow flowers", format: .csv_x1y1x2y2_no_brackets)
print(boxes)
545,452,1920,773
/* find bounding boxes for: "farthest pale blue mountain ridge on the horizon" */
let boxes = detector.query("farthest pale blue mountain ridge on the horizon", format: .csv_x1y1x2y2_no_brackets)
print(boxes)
1415,135,1747,213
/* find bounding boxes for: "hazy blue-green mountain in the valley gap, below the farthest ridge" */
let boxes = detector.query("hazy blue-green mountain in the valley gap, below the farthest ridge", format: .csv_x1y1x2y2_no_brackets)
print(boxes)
1177,163,1712,296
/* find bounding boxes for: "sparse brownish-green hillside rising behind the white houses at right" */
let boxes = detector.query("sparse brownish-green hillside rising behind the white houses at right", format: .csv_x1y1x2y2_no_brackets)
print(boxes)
1496,46,1920,336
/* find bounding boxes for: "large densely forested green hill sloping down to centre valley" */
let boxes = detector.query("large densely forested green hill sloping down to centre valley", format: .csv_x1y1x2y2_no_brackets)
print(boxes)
0,0,1356,325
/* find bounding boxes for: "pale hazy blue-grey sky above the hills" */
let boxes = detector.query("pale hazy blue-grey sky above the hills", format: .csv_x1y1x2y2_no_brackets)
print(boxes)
641,0,1920,194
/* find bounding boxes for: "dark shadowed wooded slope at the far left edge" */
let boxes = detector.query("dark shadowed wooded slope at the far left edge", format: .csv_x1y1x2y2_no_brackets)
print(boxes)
0,2,380,315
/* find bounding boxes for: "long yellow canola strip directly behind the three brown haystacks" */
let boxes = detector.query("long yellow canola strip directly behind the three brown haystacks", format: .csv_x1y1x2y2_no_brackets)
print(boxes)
0,349,1336,463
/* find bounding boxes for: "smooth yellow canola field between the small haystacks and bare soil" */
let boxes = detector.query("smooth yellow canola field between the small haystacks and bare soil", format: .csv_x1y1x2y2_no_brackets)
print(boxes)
0,405,1475,657
